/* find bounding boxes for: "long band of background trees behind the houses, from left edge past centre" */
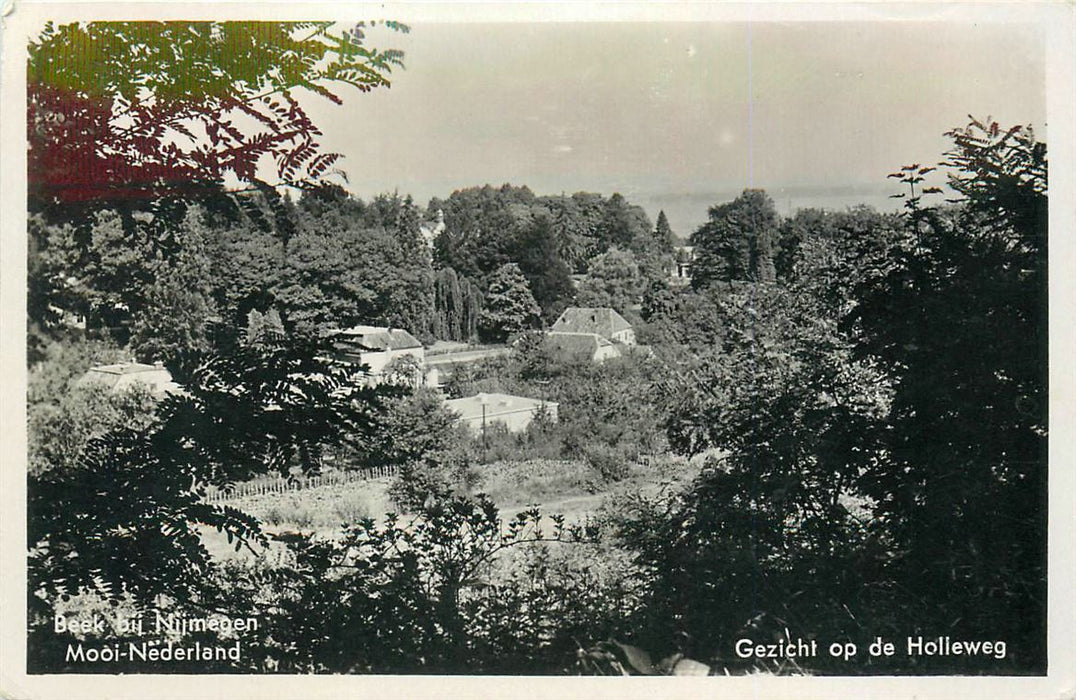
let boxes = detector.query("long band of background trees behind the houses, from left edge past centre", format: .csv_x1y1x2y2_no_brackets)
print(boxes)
29,180,684,378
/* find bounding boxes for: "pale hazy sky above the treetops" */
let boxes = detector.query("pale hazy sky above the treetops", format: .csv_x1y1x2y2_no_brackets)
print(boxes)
309,22,1046,237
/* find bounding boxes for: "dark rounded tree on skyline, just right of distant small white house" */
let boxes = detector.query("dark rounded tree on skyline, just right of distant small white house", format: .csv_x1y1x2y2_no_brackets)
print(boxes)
691,189,778,289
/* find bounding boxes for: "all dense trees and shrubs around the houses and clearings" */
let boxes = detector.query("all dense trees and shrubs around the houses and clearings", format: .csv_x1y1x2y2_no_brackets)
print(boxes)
27,23,1048,673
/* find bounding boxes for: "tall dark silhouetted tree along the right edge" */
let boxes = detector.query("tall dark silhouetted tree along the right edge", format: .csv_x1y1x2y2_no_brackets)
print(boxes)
851,120,1048,669
